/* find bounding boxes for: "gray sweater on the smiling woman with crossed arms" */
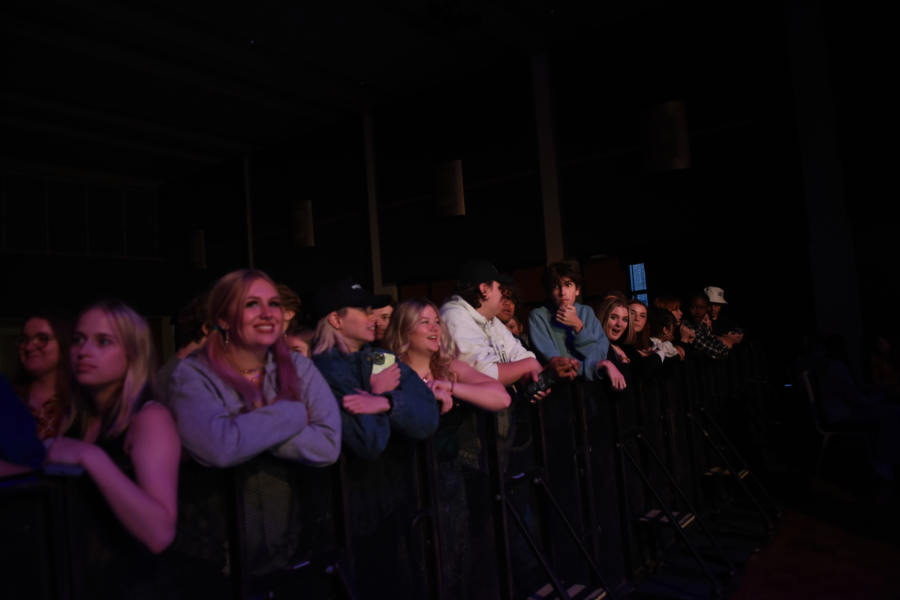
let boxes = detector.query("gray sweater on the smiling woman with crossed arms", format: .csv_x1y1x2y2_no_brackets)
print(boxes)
166,351,341,467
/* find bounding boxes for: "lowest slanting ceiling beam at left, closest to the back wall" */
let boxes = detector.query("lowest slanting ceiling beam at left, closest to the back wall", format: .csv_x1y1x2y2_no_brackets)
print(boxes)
0,90,257,157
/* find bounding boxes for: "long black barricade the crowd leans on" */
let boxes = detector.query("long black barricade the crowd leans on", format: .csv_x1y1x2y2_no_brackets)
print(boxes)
0,347,780,600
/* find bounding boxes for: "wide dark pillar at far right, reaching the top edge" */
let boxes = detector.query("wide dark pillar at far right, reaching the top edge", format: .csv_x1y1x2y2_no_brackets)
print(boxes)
773,0,862,360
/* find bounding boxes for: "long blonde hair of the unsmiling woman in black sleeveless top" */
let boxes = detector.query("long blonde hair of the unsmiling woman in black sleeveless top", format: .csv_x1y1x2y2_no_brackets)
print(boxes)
70,300,156,438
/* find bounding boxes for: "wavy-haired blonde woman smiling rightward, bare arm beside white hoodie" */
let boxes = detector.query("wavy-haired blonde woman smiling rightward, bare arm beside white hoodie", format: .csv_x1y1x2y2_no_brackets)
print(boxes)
384,298,510,412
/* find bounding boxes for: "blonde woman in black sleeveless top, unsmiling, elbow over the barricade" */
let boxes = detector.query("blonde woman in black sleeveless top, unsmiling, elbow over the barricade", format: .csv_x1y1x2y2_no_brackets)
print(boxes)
47,301,181,553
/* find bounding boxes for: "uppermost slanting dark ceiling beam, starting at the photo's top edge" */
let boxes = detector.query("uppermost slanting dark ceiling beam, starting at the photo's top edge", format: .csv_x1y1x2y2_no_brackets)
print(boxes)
57,0,385,114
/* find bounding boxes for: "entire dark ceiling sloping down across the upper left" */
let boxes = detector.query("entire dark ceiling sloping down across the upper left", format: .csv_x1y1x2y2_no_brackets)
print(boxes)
0,0,666,187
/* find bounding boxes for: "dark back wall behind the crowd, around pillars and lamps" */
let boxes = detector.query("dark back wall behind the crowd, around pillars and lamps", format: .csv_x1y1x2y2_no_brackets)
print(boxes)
0,1,900,380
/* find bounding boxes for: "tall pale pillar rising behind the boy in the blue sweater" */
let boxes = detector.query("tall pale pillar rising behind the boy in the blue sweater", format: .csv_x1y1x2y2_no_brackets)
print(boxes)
531,53,565,264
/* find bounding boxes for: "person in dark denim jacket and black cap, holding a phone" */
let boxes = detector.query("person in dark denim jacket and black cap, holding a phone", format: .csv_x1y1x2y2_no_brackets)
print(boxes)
313,277,440,460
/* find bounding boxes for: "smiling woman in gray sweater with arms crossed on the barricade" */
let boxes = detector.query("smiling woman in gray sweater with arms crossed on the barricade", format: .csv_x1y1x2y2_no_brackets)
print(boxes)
166,270,341,467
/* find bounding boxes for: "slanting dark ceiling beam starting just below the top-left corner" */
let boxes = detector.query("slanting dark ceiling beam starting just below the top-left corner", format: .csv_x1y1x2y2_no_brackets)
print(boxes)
0,15,344,123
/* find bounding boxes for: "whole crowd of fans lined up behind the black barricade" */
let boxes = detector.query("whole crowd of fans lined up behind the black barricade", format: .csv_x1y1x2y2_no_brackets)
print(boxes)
0,261,900,584
